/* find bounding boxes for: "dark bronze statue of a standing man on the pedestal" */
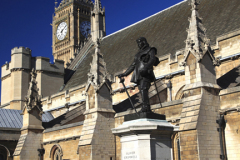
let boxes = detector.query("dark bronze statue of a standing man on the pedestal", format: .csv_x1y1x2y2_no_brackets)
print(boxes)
118,37,159,112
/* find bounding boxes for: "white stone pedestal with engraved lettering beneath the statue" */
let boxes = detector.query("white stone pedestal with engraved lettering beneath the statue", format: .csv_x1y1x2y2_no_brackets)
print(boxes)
112,115,178,160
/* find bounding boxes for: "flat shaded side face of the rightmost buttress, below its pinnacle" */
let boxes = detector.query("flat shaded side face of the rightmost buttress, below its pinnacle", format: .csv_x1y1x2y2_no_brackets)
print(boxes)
197,88,221,160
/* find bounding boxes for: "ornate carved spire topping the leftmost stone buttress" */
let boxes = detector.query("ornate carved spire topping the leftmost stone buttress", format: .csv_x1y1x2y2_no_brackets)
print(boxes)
23,69,42,113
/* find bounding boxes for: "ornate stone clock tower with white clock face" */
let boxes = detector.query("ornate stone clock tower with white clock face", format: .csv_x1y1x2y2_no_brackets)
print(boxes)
52,0,93,67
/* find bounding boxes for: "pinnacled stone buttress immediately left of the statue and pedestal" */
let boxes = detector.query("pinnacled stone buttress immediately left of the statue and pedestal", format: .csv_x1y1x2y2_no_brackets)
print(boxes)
78,39,115,160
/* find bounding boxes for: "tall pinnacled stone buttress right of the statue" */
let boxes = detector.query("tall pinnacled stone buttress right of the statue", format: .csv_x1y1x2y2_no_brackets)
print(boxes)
179,0,221,160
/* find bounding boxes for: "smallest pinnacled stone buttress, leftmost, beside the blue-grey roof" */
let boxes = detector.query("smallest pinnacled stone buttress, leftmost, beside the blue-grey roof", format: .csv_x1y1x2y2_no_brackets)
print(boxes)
13,70,44,160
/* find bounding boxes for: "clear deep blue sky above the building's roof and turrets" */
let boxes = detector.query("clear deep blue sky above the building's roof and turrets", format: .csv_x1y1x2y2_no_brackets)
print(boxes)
0,0,183,102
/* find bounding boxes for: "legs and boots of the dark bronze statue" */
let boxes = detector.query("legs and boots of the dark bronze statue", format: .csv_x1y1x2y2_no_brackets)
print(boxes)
138,80,151,112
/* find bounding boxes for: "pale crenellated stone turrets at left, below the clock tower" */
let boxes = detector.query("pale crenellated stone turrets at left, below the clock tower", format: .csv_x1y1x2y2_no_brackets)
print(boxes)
1,47,64,110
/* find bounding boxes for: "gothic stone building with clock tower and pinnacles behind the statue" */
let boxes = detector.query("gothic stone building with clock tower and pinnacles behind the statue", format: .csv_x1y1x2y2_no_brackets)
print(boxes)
0,0,240,160
